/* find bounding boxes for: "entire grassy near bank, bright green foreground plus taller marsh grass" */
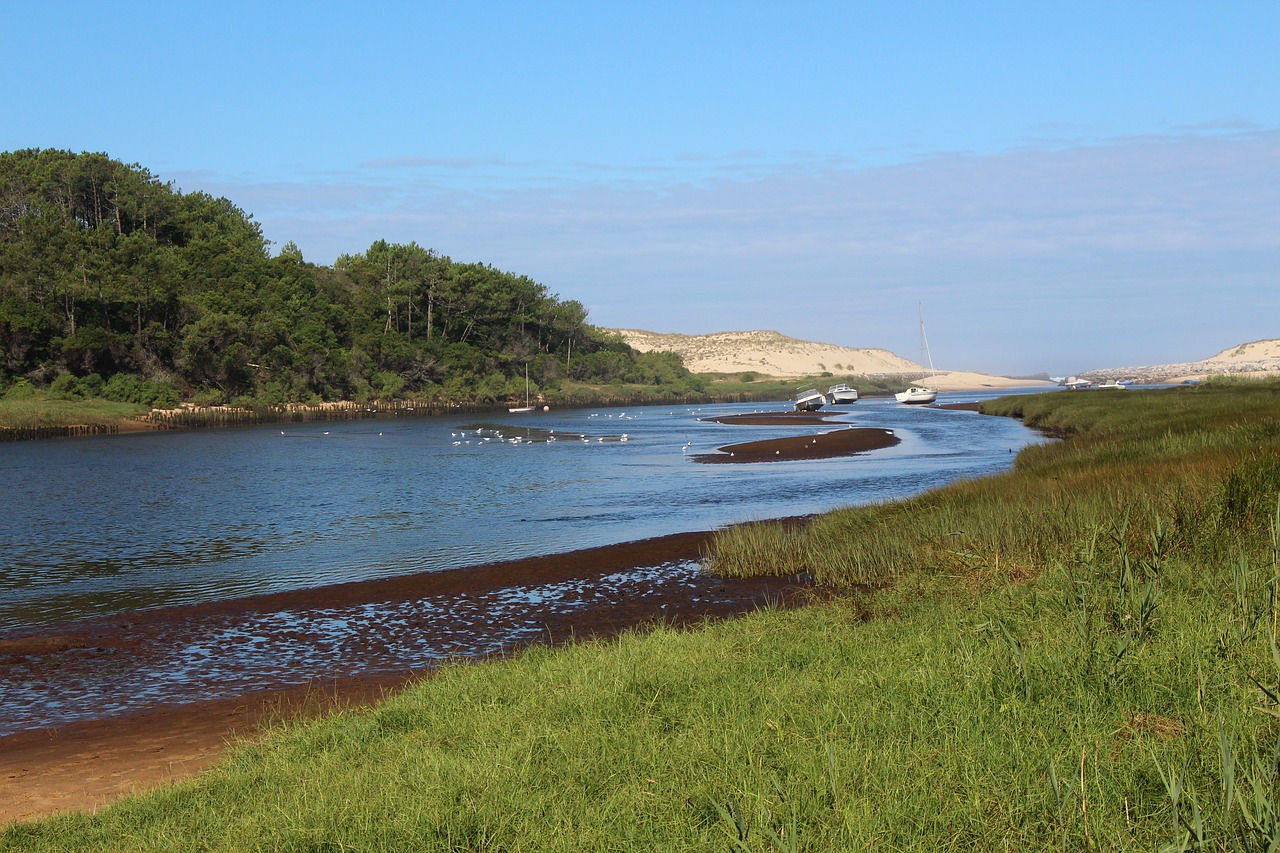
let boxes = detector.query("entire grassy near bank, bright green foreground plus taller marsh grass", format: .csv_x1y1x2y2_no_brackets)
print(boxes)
0,386,1280,850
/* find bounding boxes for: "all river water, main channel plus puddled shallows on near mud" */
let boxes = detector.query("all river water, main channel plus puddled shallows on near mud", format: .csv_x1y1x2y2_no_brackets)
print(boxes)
0,394,1042,736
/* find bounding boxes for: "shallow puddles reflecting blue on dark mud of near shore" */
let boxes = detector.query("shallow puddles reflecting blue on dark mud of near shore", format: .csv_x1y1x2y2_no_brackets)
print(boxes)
0,562,721,736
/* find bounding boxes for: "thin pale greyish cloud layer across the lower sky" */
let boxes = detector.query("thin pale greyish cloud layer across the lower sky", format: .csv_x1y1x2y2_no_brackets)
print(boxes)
185,131,1280,371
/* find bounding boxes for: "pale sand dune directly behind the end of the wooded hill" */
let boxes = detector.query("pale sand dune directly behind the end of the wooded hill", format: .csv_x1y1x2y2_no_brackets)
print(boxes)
604,329,924,377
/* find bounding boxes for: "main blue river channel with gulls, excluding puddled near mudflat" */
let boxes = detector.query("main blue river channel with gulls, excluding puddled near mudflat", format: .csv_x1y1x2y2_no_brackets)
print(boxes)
0,393,1041,631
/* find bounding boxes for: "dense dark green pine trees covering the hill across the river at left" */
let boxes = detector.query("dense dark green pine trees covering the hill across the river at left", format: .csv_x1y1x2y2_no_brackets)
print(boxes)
0,150,698,403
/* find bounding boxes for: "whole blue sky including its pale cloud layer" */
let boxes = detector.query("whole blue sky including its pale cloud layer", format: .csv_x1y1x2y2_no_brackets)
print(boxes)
0,0,1280,375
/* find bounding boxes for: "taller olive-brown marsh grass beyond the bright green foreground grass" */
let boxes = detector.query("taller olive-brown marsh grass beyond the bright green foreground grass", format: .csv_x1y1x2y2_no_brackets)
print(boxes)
708,383,1280,587
